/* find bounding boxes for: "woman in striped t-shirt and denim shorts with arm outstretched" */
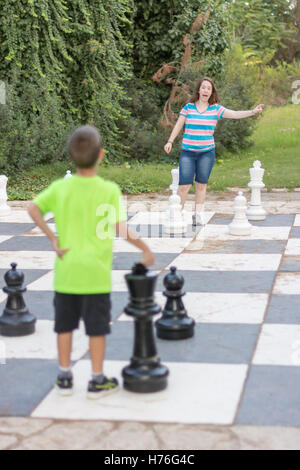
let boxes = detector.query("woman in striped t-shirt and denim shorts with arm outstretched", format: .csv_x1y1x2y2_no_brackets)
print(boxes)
164,77,264,225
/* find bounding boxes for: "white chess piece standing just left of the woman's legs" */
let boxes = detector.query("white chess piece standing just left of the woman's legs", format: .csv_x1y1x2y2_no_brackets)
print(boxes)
164,168,187,234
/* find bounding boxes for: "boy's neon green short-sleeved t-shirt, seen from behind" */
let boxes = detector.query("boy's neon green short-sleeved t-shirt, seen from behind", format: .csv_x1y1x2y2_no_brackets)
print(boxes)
33,175,127,294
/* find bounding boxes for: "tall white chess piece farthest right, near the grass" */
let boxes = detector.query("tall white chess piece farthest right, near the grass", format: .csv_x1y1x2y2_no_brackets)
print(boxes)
246,160,266,220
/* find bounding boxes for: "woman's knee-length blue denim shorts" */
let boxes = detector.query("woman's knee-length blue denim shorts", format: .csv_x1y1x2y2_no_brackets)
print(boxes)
179,149,215,185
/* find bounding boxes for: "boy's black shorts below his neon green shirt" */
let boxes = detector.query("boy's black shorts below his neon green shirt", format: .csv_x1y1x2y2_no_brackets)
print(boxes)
53,292,111,336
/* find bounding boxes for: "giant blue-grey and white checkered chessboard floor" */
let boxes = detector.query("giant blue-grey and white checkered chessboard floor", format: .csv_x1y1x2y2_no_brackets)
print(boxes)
0,211,300,426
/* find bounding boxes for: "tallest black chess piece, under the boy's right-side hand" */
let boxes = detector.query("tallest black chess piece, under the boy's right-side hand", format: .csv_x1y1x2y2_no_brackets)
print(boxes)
122,263,169,393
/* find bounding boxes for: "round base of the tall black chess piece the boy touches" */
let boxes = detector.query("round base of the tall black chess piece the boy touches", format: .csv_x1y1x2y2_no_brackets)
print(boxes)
122,362,169,393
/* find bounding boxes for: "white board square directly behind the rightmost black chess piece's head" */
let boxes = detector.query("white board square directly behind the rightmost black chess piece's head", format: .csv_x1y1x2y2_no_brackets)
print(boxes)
169,253,281,271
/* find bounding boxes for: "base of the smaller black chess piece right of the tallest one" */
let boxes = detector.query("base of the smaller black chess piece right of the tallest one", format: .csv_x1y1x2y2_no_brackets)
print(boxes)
155,317,195,340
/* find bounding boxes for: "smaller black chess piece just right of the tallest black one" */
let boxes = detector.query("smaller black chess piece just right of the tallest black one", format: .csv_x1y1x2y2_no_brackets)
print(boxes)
155,266,195,340
